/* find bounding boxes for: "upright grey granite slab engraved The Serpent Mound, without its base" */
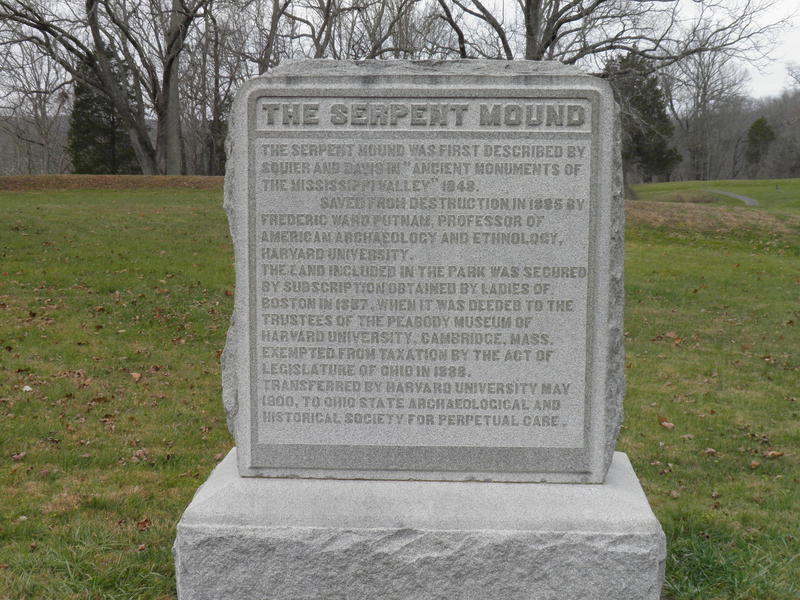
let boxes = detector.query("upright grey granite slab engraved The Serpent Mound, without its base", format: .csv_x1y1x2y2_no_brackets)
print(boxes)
223,61,624,482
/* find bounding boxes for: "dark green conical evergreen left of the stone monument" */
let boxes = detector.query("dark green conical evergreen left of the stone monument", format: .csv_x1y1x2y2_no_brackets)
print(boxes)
67,51,141,175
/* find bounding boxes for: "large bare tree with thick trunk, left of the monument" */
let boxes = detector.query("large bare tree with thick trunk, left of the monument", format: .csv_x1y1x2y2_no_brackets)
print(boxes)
0,0,208,174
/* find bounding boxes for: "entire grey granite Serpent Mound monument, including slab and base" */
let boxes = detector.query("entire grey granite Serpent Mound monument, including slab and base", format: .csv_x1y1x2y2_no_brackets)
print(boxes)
174,61,665,600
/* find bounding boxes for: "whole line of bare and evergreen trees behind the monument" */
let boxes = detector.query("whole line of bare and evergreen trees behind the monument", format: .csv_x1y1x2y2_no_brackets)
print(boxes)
0,0,800,180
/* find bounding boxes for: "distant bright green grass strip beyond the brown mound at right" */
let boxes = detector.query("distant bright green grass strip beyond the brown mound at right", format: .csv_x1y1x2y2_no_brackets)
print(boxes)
633,179,800,215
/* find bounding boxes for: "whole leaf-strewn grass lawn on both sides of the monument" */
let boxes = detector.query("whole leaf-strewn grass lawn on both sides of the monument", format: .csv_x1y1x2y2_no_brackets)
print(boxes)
0,180,800,600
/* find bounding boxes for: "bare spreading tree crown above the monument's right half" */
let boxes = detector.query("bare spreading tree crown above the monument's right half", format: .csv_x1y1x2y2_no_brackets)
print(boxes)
432,0,788,65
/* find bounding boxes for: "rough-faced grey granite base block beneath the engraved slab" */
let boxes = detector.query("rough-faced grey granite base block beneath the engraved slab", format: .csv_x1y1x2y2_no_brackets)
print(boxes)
173,448,666,600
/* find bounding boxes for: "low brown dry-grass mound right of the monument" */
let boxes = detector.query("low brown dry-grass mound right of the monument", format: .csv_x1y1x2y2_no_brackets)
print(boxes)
625,200,800,236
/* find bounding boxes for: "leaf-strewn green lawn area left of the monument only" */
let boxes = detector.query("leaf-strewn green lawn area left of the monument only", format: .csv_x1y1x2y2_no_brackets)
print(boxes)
0,190,233,599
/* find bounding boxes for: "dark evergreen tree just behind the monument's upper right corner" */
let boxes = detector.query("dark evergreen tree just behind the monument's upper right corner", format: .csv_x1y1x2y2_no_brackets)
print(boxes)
604,54,682,181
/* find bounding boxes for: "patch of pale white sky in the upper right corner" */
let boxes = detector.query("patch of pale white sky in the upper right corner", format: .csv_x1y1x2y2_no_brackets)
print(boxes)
748,0,800,98
